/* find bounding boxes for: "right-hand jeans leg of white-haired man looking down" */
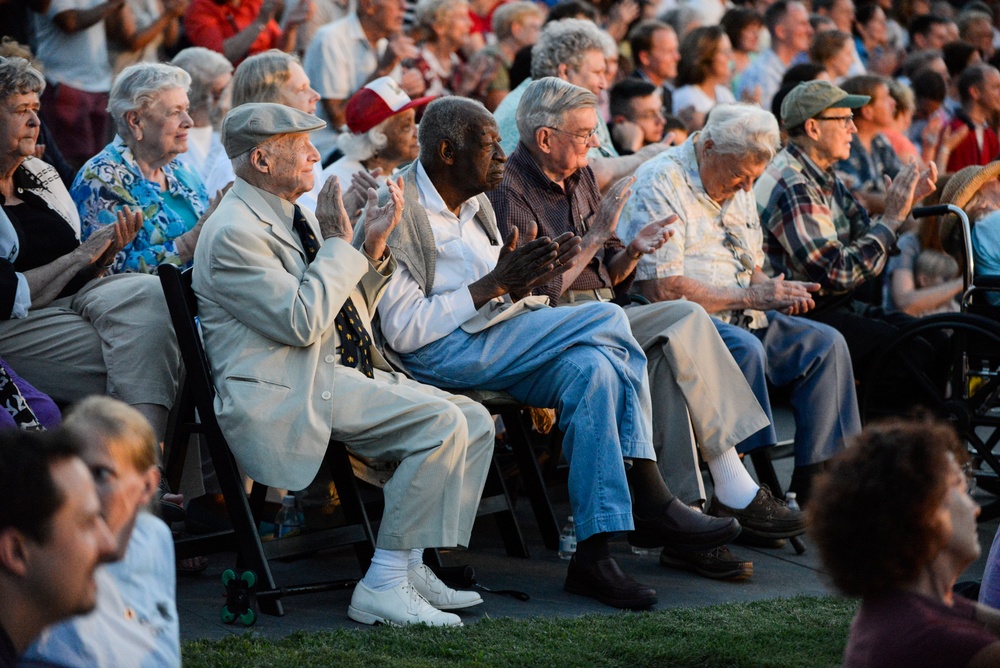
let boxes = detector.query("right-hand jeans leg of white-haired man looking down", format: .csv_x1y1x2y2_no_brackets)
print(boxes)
757,311,861,466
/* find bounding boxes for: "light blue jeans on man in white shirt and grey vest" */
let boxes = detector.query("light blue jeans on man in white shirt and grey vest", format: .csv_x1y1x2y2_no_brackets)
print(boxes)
401,302,656,540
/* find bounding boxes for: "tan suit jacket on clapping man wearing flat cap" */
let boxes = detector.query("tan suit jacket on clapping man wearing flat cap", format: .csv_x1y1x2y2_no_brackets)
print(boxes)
194,178,395,489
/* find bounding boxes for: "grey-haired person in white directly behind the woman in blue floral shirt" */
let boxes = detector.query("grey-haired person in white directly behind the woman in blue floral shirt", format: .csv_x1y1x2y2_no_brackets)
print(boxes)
170,46,233,183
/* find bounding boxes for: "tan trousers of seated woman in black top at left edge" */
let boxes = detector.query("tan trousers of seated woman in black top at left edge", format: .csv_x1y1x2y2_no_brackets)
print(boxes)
0,274,181,409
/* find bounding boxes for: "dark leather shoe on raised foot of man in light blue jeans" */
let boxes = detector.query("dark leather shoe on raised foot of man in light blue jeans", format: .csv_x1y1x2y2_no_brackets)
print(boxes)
628,499,740,550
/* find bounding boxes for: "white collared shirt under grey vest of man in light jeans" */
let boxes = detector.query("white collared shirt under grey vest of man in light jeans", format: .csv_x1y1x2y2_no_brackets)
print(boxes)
378,162,501,353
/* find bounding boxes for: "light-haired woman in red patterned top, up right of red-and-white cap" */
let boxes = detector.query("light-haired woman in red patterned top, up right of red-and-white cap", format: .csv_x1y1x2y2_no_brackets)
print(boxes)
415,0,472,97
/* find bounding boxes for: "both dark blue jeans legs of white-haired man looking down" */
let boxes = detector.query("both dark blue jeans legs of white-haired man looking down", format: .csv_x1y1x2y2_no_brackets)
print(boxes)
713,311,861,466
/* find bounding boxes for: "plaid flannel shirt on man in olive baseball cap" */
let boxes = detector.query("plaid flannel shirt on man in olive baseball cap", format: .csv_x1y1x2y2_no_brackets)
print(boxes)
754,143,896,295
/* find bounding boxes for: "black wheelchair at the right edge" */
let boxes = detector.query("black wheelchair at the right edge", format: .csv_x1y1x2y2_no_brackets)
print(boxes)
859,204,1000,521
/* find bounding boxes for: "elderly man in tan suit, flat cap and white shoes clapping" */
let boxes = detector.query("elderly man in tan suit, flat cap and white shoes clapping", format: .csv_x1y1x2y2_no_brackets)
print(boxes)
194,104,493,626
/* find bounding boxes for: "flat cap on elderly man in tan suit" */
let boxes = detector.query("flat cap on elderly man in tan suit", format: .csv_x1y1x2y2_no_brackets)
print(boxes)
222,102,326,159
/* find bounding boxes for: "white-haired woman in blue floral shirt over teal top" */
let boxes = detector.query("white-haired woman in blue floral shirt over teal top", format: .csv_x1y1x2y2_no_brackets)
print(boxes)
70,63,221,273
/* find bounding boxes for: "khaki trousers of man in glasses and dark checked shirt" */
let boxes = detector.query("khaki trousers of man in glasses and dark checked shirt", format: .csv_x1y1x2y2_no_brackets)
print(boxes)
625,300,768,503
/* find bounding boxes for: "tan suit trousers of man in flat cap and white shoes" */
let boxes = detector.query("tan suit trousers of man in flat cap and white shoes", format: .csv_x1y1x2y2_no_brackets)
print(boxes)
332,365,494,550
